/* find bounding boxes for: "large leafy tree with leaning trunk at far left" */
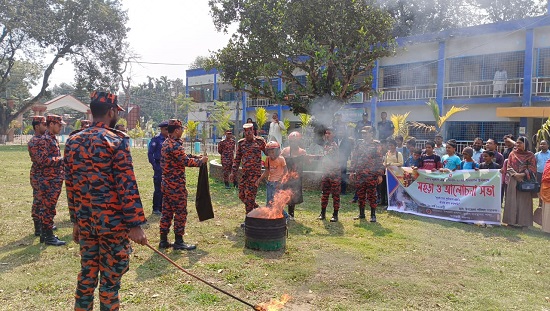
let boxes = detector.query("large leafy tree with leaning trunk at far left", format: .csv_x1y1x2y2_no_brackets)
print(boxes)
0,0,128,139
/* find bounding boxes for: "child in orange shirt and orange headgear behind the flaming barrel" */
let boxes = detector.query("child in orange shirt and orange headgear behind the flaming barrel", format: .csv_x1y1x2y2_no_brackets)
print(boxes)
256,141,287,211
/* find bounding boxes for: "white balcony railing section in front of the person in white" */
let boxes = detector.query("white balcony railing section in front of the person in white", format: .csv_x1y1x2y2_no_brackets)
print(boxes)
445,78,523,98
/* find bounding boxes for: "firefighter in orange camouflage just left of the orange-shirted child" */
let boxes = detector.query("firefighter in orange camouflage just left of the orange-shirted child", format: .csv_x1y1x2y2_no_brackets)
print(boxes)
229,123,266,223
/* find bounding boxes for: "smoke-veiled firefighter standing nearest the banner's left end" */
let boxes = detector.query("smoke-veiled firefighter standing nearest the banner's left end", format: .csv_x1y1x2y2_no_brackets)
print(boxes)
351,126,385,222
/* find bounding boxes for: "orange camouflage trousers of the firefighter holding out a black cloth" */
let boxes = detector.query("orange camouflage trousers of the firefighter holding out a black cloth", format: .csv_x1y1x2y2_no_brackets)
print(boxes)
159,191,187,235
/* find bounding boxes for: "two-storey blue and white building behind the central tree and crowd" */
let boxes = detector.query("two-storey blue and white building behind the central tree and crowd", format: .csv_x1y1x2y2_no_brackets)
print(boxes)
186,9,550,141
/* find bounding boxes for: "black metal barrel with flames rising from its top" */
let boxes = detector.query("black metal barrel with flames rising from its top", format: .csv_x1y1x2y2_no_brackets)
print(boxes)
244,216,287,251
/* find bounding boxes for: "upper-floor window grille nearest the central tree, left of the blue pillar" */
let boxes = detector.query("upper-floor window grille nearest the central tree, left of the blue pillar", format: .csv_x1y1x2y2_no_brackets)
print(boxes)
380,61,437,87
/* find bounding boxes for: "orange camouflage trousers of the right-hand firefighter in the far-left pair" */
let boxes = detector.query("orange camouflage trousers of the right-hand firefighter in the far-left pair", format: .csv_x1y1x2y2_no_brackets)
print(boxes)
38,178,63,229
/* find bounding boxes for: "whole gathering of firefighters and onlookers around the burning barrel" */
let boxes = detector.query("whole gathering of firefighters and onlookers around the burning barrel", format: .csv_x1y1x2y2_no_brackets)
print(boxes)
28,97,550,310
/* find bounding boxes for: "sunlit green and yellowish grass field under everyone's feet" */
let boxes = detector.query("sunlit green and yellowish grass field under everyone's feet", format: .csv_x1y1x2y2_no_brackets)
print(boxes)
0,146,550,310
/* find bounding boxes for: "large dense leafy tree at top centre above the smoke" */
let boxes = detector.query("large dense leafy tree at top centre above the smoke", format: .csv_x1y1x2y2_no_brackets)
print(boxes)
209,0,395,114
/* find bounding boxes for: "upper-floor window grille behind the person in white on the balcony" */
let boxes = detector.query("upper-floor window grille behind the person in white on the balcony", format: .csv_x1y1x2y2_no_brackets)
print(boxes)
447,51,525,82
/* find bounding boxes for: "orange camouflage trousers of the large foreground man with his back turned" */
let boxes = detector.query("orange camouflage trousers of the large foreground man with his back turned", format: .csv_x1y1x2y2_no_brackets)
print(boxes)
74,231,131,311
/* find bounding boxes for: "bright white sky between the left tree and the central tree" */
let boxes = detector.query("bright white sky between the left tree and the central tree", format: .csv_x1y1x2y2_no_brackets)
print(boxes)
50,0,235,90
